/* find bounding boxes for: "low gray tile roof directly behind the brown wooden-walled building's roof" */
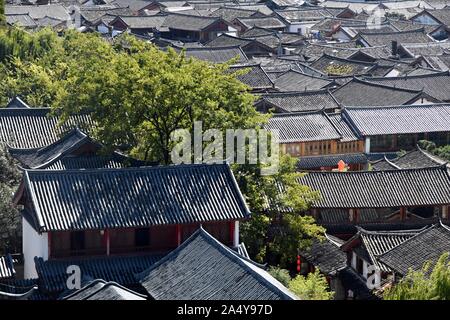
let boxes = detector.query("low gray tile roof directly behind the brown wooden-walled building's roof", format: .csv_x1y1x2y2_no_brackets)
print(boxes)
258,89,340,113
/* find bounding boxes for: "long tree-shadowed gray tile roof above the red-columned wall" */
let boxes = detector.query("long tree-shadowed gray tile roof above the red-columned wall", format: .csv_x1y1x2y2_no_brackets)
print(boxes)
19,164,249,232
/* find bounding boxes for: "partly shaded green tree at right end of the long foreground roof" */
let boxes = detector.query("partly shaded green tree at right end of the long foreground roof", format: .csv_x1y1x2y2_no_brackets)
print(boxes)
239,155,324,268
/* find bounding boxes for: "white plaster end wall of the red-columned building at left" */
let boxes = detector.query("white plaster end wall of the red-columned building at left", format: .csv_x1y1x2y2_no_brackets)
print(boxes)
22,218,48,279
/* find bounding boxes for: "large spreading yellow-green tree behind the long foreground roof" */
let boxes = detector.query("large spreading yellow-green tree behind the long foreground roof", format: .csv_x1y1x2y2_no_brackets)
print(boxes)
56,36,266,164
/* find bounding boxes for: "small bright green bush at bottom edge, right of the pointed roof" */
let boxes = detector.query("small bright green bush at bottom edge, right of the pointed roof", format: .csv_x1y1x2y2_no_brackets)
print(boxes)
289,269,334,300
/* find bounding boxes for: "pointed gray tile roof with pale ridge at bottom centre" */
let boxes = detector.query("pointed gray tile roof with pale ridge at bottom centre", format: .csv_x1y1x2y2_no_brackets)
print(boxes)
140,229,296,300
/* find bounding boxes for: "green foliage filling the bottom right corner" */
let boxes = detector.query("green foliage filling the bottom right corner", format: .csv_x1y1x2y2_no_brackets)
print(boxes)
383,252,450,300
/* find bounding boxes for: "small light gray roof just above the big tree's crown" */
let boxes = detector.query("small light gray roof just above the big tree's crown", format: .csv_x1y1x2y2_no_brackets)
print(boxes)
179,46,248,63
